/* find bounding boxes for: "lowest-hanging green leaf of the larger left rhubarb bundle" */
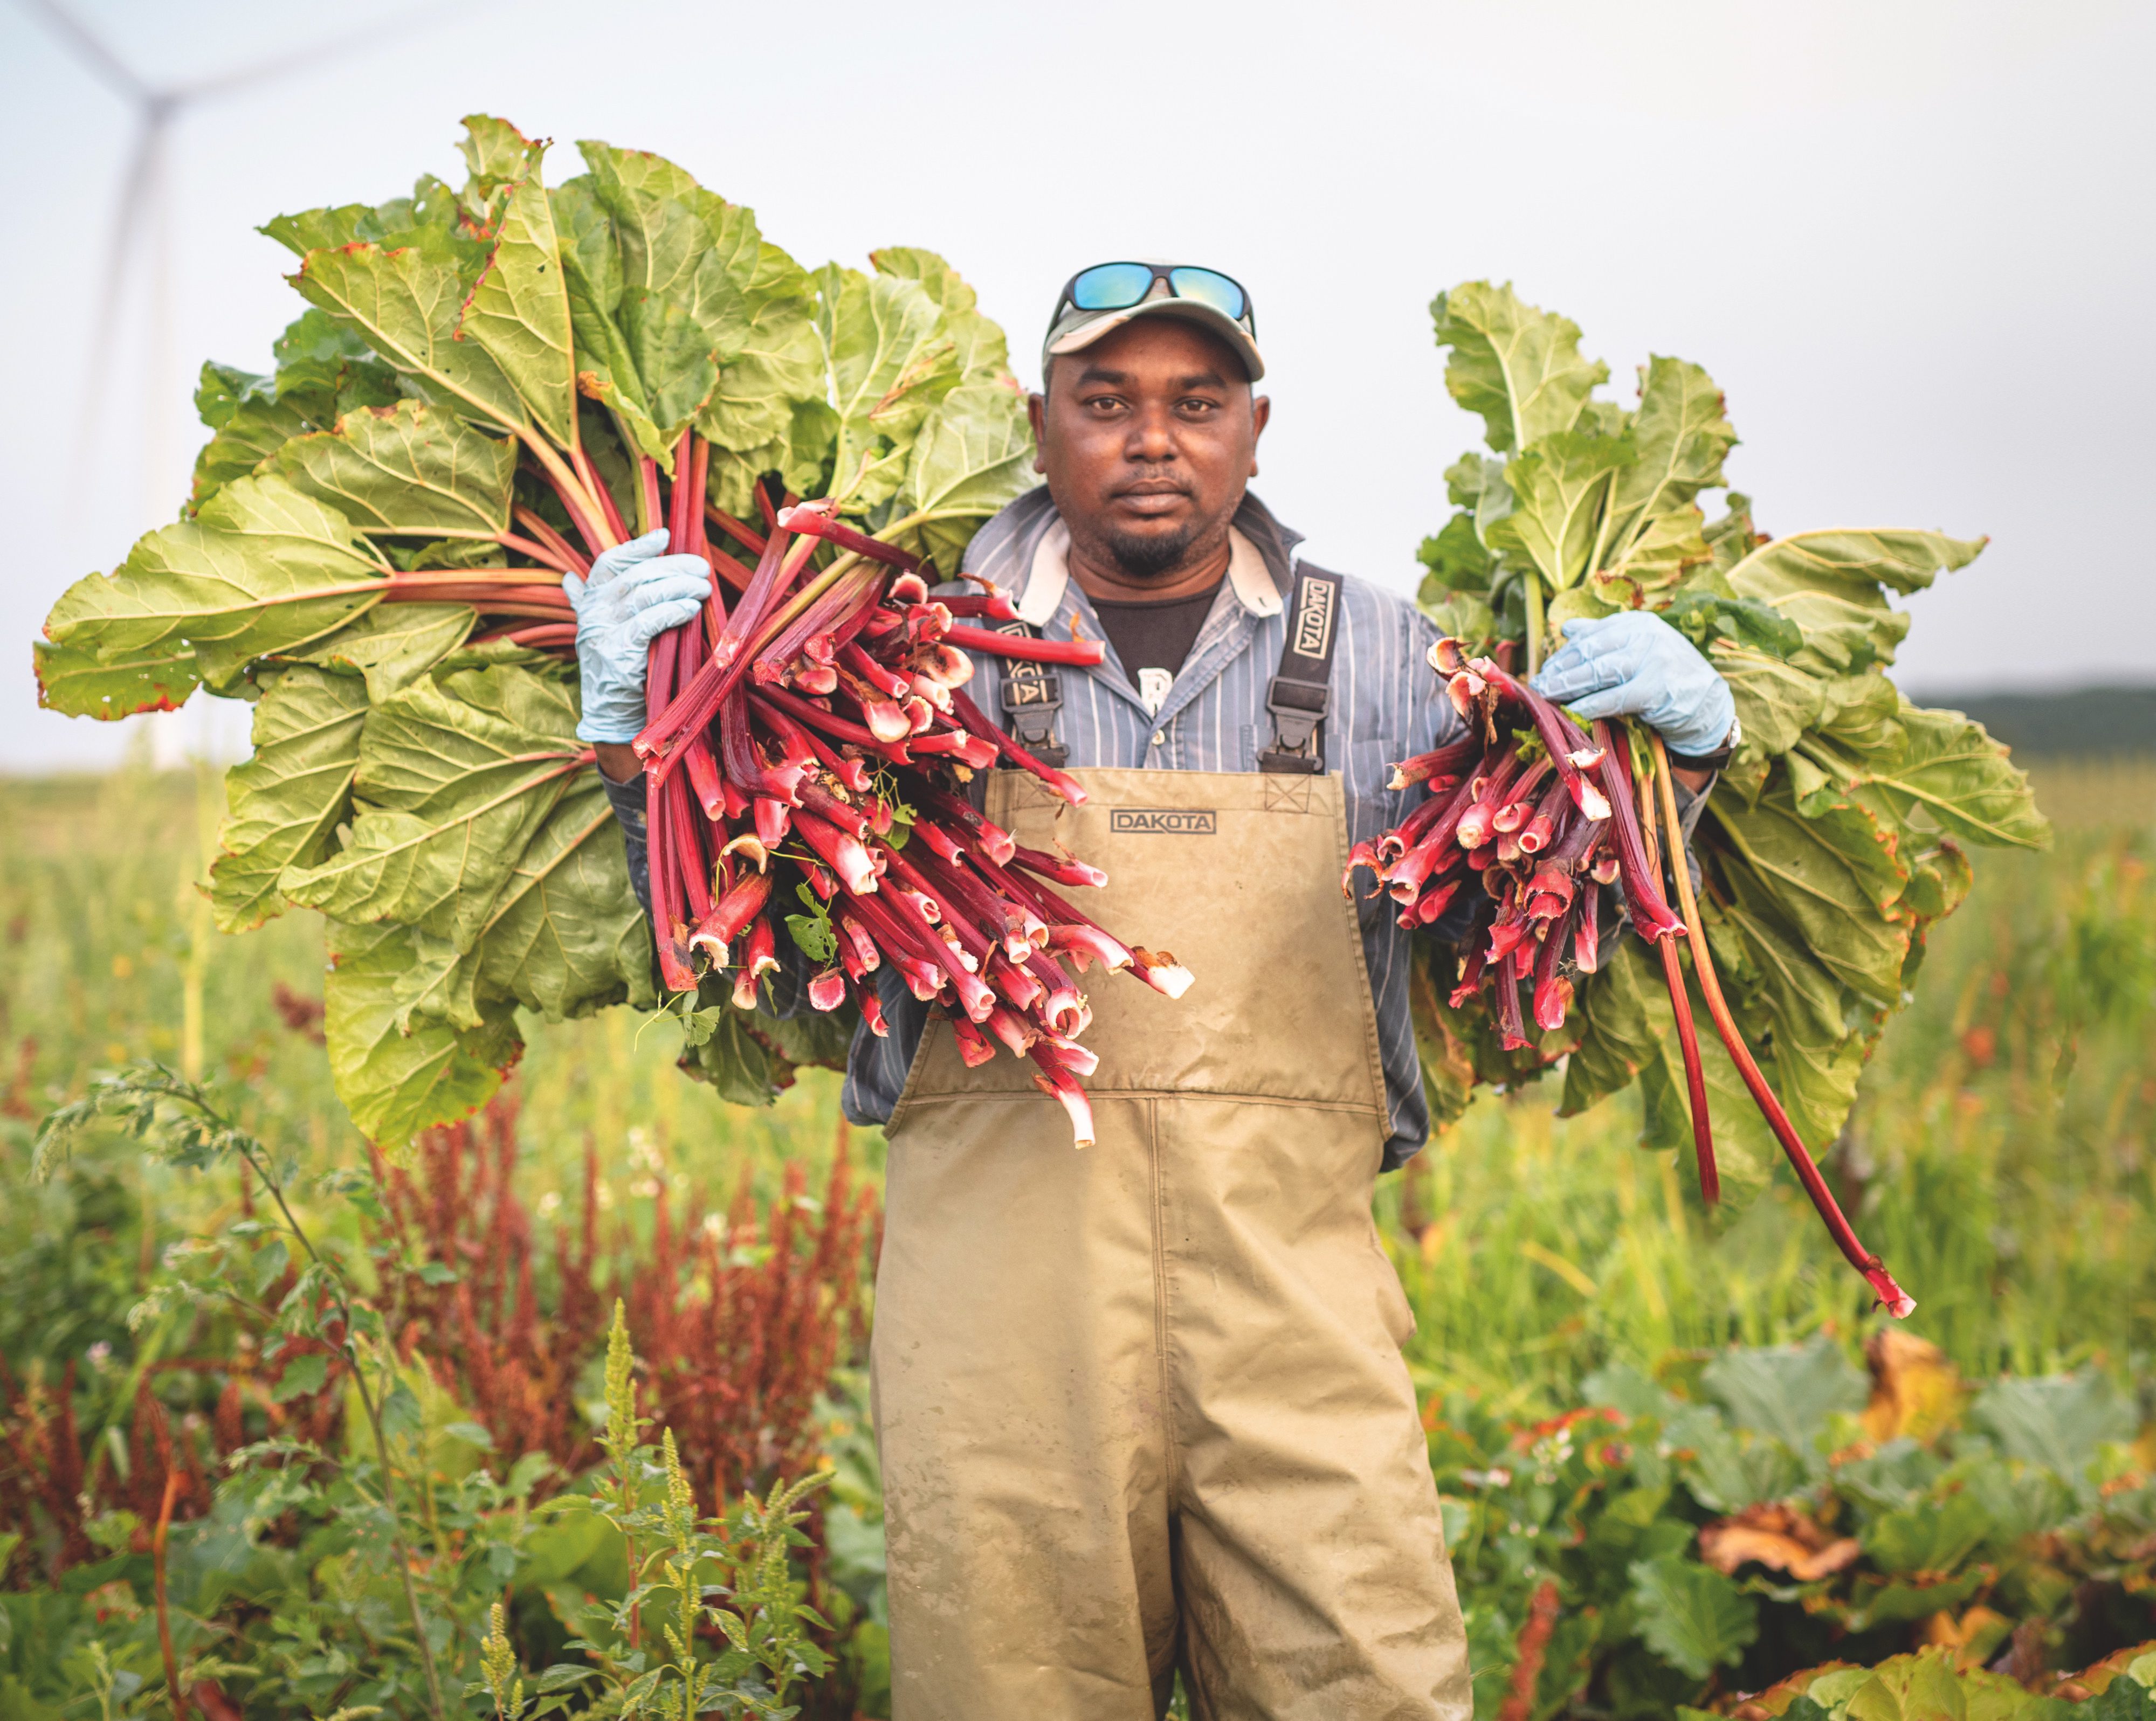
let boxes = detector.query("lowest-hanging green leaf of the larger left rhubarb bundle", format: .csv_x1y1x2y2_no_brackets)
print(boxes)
321,921,524,1148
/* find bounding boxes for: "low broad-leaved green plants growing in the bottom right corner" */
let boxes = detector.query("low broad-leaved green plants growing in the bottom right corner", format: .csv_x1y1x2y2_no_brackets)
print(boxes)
1425,1344,2156,1719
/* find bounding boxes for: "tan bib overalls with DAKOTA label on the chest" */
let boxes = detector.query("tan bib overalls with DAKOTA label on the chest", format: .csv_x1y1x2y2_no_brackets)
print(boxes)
873,768,1470,1721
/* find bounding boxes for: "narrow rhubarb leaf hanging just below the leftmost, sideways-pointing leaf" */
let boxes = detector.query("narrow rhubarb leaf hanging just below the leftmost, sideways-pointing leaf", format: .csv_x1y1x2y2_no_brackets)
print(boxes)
209,668,367,932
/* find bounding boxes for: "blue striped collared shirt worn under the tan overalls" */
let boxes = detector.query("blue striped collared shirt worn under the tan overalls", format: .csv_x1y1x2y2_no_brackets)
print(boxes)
845,487,1459,1169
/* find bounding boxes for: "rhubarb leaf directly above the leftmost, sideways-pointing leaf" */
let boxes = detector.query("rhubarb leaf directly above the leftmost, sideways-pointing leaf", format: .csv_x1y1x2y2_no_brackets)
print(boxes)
276,401,518,539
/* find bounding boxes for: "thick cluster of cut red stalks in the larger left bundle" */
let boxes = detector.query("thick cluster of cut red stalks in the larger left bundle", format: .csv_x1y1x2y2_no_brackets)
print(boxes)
636,472,1190,1148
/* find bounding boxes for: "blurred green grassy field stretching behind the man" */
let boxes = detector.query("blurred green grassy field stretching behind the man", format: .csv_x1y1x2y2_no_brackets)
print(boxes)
0,759,2156,1719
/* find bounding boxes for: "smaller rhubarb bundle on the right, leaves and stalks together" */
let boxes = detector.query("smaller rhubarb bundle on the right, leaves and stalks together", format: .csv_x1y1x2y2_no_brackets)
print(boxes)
1397,282,2048,1307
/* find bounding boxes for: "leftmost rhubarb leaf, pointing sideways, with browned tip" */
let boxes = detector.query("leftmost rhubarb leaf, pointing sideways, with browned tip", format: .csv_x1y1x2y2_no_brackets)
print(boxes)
45,474,382,692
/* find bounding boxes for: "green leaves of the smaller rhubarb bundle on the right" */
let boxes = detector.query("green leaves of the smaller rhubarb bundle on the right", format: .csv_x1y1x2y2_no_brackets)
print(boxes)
1414,282,2050,1210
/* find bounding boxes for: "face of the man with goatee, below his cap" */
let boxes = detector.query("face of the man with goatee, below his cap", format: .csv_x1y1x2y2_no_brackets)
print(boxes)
1033,317,1270,580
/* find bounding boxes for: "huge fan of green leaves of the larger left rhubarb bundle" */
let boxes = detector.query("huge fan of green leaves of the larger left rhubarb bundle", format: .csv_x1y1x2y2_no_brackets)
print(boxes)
37,116,1043,1143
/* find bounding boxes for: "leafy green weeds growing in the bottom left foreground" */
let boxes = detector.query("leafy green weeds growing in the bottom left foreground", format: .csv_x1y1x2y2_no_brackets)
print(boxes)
0,1066,858,1721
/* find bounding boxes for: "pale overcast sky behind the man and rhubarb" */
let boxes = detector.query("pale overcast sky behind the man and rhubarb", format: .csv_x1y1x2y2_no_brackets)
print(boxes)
0,0,2156,770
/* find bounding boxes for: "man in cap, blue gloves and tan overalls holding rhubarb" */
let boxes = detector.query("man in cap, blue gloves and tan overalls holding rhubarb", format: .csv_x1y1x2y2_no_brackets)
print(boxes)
580,263,1731,1721
